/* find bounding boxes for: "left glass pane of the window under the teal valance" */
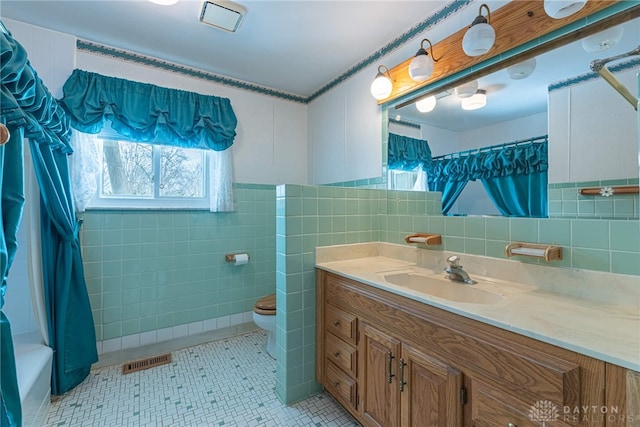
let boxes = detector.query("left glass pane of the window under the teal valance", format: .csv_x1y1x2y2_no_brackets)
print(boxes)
102,140,153,197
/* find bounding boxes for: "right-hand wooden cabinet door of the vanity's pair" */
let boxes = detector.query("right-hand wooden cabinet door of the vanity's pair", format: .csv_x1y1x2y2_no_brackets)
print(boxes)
398,343,462,427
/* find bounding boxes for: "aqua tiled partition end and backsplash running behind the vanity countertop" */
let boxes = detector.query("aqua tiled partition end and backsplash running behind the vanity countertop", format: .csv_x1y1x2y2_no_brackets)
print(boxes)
276,185,640,403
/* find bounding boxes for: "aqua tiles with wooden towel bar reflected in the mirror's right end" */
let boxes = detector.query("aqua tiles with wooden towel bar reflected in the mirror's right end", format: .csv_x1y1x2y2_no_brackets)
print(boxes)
549,178,640,219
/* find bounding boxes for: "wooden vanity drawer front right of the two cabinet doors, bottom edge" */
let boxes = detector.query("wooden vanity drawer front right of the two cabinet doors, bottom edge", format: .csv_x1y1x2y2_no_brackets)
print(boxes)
471,382,570,427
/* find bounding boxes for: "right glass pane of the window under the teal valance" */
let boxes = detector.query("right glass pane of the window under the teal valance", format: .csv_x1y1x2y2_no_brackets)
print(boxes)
160,146,204,197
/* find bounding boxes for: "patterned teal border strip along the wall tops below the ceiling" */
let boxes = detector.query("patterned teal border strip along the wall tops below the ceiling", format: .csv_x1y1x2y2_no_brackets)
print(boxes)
76,0,473,104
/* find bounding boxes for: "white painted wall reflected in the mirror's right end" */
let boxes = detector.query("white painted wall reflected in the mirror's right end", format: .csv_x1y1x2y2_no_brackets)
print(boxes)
549,69,639,183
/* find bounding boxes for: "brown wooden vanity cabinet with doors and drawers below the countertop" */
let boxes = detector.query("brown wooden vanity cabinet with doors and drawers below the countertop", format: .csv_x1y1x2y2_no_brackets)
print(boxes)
316,270,619,427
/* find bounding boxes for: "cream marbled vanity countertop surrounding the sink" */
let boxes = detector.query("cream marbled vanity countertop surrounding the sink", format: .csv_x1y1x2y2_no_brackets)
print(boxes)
316,242,640,372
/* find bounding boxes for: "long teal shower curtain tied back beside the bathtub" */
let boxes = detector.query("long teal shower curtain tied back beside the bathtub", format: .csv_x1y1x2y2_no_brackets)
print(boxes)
0,21,98,425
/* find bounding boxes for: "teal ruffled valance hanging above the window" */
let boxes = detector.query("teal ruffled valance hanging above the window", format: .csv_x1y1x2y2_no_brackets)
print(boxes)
60,69,237,151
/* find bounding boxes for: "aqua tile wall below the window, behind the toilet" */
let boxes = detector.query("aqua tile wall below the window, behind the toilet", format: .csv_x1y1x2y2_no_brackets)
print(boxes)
82,184,276,341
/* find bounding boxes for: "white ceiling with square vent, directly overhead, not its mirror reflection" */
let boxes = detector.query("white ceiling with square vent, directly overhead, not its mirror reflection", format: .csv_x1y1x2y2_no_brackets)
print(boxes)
0,0,449,97
